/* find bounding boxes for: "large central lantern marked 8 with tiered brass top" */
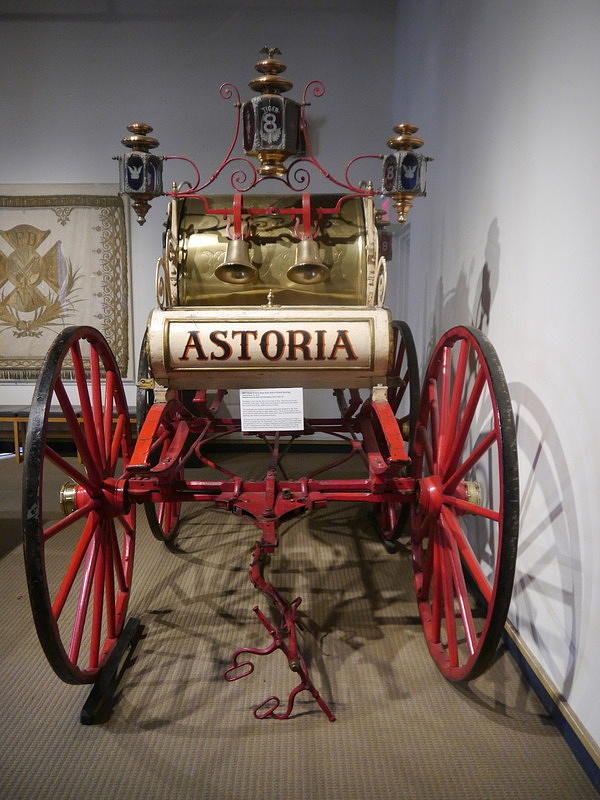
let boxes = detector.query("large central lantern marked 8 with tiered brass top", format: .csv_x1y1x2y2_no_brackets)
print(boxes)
242,47,302,178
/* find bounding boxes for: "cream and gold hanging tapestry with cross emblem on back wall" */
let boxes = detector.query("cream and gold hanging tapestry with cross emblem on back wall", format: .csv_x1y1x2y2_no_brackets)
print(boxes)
0,194,129,381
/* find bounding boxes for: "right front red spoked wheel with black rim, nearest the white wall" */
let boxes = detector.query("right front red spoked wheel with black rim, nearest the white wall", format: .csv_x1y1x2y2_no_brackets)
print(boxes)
411,327,519,680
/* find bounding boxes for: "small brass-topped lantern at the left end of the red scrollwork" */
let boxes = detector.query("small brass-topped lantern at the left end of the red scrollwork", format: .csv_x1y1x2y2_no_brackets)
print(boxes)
116,122,163,225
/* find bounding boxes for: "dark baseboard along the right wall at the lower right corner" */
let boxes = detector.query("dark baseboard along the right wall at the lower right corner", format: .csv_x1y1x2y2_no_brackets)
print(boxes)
504,621,600,792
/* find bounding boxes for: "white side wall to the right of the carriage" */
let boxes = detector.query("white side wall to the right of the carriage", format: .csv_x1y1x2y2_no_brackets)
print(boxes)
394,0,600,742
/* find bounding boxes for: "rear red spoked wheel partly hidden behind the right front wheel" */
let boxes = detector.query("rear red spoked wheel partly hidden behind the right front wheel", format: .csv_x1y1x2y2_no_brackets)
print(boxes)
374,321,420,553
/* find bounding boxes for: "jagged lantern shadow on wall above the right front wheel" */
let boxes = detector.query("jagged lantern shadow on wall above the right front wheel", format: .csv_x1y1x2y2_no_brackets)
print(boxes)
427,217,500,353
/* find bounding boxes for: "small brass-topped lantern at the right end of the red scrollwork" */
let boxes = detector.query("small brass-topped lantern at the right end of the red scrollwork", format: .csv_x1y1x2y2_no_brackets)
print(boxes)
382,122,432,223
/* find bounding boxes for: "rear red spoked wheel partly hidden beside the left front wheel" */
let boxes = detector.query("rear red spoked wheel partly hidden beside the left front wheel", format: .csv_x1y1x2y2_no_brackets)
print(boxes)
136,333,183,545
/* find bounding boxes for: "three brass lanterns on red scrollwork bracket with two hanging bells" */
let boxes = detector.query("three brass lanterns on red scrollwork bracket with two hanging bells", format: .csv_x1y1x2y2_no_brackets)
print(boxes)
115,47,432,227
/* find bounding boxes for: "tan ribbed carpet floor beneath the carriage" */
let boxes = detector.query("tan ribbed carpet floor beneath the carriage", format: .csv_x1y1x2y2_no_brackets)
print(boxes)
0,454,597,800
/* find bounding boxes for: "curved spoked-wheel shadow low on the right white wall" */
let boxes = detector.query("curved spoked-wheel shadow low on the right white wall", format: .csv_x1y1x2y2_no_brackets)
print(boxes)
509,383,581,698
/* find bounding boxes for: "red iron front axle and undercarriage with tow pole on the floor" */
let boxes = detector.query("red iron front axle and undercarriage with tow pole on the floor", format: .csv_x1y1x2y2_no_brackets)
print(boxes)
118,391,415,721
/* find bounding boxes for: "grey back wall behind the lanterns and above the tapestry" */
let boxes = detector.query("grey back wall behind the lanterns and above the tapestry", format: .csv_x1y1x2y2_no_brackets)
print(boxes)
0,0,395,412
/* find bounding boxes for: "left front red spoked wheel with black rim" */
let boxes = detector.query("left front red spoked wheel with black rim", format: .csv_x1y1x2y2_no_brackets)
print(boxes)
23,327,135,683
